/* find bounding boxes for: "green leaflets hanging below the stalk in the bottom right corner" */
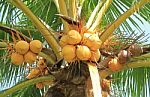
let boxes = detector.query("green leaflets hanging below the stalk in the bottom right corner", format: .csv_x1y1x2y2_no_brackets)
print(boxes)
111,68,150,97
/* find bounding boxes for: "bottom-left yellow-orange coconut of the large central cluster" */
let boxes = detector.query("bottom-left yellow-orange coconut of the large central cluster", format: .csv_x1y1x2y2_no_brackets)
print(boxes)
62,45,76,62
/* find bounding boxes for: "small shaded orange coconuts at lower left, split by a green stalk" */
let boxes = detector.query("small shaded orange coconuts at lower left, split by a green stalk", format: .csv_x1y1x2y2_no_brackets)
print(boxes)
26,58,51,89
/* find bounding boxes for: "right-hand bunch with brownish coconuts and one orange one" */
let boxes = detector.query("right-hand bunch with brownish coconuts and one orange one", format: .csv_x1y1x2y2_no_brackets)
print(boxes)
101,44,143,71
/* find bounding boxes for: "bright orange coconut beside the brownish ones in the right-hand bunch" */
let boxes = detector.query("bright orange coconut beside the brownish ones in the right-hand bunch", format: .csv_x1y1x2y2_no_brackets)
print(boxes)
108,57,122,71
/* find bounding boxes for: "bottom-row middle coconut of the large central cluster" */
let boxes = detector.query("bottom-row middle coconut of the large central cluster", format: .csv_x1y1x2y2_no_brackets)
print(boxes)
76,45,91,60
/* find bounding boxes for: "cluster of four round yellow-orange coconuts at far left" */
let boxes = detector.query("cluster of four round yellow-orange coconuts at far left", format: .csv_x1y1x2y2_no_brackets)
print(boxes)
11,40,42,65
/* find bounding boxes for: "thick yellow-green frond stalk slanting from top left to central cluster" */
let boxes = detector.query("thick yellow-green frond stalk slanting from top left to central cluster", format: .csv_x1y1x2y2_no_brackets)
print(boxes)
8,0,61,59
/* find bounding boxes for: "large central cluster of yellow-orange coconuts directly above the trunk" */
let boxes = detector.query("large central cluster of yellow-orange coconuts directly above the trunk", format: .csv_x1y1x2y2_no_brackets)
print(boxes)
59,30,102,62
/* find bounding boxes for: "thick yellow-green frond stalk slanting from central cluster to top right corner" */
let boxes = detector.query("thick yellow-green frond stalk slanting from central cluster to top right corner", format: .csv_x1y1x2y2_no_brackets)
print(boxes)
100,0,150,42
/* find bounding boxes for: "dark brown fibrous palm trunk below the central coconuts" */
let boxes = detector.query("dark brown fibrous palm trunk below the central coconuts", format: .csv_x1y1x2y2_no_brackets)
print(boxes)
45,63,89,97
